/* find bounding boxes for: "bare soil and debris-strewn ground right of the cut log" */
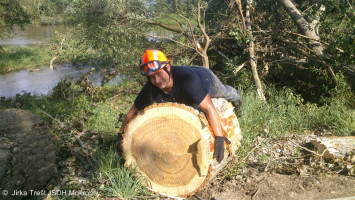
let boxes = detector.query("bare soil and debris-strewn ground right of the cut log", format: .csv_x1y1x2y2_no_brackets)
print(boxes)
187,135,355,200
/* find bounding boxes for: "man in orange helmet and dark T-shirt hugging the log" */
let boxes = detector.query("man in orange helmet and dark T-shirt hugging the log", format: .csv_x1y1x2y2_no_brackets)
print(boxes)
119,49,241,162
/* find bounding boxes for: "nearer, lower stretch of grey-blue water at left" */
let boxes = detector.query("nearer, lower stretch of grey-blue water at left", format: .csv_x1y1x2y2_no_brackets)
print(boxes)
0,64,122,98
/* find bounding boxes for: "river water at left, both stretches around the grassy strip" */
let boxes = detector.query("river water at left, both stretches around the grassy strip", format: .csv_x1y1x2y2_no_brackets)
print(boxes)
0,25,122,98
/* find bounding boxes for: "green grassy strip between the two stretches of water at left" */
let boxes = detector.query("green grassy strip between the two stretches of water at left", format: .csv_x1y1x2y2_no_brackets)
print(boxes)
0,47,53,73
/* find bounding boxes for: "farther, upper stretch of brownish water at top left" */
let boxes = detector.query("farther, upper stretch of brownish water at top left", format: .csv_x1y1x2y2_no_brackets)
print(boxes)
0,25,68,47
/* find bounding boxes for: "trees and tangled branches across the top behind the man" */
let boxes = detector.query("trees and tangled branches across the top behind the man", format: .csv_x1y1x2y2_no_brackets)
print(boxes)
31,0,355,101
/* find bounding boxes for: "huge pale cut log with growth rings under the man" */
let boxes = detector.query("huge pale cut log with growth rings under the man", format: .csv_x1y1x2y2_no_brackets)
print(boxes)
122,99,242,197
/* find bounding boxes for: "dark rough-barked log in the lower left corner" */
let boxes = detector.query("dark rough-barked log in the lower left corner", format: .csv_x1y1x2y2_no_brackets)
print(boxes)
0,109,56,199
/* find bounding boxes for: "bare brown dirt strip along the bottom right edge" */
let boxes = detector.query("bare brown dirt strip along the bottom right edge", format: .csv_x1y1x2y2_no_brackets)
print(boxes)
188,168,355,200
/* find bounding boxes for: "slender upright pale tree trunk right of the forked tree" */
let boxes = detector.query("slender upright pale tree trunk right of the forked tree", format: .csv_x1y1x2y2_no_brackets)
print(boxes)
245,1,266,102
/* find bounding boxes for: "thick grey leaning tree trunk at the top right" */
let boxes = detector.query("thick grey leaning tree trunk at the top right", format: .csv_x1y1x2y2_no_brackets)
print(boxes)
276,0,337,85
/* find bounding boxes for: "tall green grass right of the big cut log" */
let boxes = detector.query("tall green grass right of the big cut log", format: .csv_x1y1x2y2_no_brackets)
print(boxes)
238,83,355,156
